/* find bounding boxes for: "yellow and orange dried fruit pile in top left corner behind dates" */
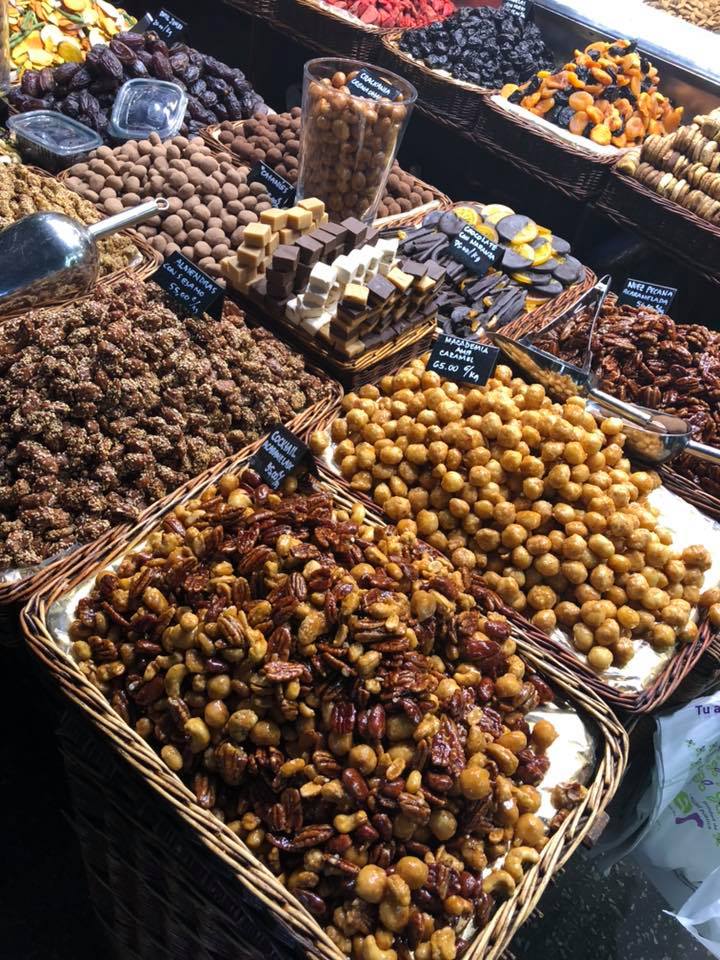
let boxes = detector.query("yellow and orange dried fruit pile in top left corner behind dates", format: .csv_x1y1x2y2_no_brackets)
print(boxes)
8,0,136,73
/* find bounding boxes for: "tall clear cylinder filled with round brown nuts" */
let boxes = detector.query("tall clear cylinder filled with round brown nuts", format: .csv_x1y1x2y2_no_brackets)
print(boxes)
297,58,417,222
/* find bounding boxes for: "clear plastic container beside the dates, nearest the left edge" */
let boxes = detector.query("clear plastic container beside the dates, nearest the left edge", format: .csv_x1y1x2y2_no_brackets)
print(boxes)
7,110,102,172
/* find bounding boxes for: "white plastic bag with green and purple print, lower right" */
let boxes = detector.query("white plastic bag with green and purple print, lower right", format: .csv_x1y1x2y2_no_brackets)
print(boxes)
634,692,720,958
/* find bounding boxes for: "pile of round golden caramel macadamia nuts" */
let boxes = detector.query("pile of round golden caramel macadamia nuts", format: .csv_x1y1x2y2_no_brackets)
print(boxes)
320,359,713,671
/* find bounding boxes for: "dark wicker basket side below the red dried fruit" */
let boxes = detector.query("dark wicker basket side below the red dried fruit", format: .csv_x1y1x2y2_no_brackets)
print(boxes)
273,0,385,63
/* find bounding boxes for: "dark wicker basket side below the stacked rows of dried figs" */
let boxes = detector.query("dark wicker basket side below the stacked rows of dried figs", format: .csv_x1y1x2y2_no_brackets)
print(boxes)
595,169,720,283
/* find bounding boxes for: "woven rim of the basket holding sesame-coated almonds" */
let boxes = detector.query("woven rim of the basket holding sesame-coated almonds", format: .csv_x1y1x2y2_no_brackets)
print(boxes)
0,296,344,608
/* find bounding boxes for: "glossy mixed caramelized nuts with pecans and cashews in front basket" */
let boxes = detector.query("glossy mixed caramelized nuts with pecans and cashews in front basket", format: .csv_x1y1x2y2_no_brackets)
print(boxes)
70,471,572,960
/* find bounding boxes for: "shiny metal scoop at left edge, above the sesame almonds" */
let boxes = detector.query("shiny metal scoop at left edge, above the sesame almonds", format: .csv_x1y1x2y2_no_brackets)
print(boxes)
0,197,168,313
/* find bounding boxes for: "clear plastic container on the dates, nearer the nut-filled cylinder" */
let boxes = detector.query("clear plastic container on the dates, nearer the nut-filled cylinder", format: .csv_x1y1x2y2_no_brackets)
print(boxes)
108,79,187,142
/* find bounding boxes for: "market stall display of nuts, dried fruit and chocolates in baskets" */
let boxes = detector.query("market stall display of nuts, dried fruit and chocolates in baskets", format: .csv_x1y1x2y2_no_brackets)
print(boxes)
0,0,720,960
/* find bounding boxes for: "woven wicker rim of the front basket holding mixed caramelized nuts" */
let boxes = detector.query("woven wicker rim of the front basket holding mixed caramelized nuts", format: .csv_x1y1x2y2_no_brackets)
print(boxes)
21,457,628,960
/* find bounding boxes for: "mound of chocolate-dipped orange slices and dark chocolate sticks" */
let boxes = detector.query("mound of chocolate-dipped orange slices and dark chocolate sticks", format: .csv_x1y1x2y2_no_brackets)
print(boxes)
401,210,585,339
